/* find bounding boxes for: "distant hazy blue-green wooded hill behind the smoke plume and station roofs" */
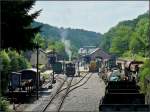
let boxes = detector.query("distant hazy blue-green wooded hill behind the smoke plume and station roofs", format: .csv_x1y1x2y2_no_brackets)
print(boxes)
32,22,103,48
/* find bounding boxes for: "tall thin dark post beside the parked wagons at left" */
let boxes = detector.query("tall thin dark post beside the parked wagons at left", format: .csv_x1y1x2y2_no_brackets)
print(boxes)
36,43,39,100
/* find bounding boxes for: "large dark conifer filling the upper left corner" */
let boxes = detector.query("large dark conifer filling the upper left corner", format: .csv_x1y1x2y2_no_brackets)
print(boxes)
1,0,41,51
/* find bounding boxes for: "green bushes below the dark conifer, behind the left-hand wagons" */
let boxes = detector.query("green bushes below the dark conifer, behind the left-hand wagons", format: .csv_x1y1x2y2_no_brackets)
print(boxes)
0,50,31,94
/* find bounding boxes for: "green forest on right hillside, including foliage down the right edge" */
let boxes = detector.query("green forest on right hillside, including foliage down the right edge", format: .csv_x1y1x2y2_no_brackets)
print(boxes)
101,12,150,94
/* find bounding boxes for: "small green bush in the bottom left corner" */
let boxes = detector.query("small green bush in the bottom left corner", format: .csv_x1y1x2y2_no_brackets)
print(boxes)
0,97,11,112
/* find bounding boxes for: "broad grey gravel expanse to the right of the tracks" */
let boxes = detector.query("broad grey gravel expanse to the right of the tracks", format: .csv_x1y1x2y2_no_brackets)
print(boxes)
61,73,105,112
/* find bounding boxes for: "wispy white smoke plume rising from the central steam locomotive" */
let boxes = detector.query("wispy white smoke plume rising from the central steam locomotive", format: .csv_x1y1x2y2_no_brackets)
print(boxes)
60,28,72,61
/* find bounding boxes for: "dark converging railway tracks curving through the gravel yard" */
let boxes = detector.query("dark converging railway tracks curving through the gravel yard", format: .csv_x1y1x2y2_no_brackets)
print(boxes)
40,73,92,112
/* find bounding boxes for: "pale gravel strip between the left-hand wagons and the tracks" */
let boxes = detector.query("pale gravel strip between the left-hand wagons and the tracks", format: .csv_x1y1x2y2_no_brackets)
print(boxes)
9,75,66,112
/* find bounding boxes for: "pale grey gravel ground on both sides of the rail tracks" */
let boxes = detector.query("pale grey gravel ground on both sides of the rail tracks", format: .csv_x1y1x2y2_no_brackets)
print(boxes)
8,73,105,112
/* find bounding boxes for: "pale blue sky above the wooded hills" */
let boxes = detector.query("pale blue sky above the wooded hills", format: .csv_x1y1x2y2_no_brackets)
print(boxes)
29,1,149,34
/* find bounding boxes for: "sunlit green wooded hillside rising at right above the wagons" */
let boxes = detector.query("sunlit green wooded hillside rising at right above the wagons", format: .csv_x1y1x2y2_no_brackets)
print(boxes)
101,12,150,57
